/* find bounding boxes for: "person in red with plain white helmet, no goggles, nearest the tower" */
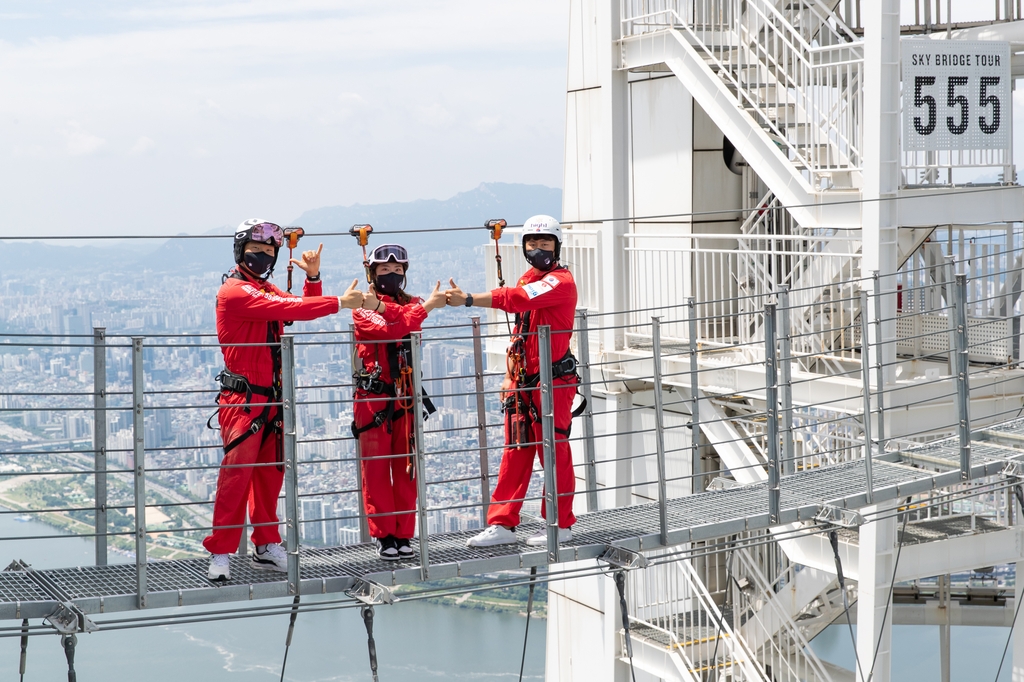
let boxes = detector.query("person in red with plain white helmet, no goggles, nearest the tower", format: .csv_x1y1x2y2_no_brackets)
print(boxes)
445,215,579,547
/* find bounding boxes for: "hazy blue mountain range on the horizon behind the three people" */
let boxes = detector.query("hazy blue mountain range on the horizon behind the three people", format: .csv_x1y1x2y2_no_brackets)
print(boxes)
0,182,562,273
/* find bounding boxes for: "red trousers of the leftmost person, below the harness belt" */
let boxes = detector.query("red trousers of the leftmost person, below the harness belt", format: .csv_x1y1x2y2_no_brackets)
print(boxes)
203,391,285,554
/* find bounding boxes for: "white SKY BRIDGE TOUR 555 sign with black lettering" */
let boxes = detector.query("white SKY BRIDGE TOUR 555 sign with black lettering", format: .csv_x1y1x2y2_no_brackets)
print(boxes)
902,39,1013,152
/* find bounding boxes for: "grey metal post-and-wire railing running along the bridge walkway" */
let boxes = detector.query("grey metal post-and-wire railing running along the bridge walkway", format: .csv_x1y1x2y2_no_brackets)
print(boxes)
0,240,1024,604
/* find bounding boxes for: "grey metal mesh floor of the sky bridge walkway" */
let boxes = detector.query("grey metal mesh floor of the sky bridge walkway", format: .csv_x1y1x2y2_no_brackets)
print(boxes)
6,419,1024,614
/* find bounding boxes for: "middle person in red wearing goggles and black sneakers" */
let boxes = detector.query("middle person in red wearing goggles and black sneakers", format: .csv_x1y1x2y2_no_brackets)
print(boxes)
352,244,445,561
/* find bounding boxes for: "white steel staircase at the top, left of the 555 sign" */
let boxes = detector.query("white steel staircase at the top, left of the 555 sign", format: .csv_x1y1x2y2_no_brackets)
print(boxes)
622,0,863,212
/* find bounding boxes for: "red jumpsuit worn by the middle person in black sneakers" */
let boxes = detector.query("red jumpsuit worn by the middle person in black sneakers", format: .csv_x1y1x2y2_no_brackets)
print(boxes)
352,294,427,539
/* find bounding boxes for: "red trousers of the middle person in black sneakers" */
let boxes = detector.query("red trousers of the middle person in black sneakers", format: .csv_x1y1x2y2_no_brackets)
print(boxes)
354,391,416,538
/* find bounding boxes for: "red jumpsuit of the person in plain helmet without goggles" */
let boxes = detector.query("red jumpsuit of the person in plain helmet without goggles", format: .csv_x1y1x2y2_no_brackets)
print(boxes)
487,267,577,528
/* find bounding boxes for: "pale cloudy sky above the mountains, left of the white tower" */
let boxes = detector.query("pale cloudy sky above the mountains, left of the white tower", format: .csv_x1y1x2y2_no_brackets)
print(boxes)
0,0,568,235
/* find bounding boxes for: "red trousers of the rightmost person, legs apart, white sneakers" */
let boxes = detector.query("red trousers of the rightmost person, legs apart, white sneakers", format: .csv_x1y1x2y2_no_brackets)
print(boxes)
487,377,575,528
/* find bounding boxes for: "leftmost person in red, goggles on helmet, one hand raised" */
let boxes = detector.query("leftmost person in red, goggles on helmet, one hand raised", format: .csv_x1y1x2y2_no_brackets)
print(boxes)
203,219,365,581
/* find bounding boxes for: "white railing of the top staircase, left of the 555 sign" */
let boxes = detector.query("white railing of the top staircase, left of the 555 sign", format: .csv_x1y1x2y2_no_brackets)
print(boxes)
622,0,863,187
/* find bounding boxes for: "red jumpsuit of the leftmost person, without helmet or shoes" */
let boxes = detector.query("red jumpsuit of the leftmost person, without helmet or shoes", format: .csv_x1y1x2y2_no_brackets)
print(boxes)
203,270,339,554
